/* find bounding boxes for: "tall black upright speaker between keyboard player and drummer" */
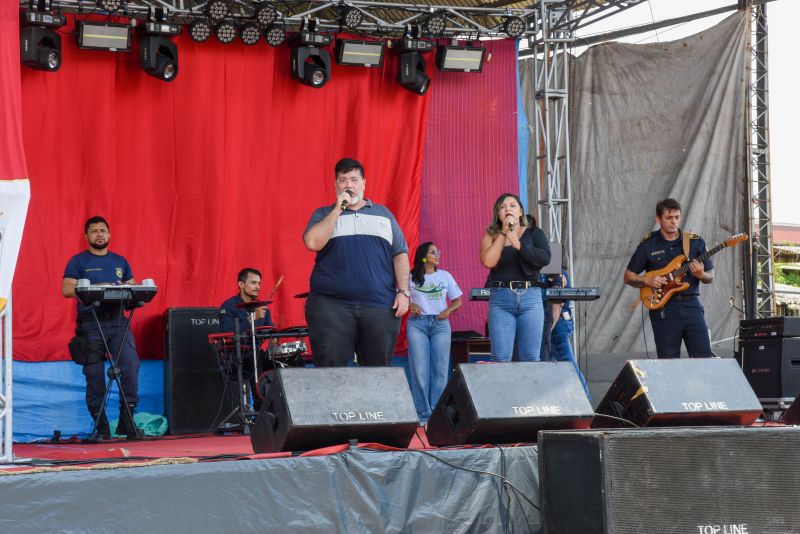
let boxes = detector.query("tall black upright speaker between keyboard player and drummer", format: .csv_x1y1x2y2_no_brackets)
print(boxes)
164,308,227,434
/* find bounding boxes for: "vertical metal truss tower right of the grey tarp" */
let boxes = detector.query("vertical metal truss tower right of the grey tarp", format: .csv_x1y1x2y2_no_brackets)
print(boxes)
745,4,775,318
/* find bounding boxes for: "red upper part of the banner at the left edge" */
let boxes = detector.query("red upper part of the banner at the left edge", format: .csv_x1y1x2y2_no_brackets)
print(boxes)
0,1,28,180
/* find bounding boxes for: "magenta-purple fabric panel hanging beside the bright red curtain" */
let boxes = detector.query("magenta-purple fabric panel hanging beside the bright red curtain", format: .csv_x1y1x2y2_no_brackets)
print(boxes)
418,39,519,333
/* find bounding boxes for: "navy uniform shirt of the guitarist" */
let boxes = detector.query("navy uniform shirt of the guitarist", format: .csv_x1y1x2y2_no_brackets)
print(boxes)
628,230,714,297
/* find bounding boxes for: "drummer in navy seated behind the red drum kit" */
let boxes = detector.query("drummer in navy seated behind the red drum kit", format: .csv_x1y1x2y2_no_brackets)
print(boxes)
219,267,275,411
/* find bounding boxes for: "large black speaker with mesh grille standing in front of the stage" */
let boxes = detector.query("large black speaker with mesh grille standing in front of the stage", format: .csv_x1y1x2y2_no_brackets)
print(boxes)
539,427,800,534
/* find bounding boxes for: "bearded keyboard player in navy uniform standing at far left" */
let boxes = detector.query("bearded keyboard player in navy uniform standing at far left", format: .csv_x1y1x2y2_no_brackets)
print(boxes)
61,216,144,439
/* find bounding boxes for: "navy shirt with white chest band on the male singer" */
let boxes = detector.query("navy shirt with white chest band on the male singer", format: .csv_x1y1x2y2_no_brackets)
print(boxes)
306,200,408,307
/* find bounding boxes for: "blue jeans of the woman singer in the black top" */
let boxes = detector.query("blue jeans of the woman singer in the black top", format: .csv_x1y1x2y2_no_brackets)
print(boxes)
489,287,544,362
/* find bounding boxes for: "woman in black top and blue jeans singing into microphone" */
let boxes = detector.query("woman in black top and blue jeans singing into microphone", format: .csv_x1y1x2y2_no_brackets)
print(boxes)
481,193,550,362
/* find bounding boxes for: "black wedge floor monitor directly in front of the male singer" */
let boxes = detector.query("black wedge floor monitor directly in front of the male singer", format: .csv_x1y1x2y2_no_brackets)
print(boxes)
250,367,419,453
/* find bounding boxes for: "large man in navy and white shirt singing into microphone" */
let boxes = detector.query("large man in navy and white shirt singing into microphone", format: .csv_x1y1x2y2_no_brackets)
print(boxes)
303,158,410,367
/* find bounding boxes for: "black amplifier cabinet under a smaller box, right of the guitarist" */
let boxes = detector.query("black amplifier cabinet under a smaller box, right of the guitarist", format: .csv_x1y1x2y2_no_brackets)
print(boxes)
737,338,800,399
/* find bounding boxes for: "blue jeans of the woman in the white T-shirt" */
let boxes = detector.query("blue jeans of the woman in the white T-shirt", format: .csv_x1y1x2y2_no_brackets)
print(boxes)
406,315,450,423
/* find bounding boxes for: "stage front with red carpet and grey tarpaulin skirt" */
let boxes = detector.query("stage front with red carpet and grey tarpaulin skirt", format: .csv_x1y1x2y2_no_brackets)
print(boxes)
0,434,540,533
